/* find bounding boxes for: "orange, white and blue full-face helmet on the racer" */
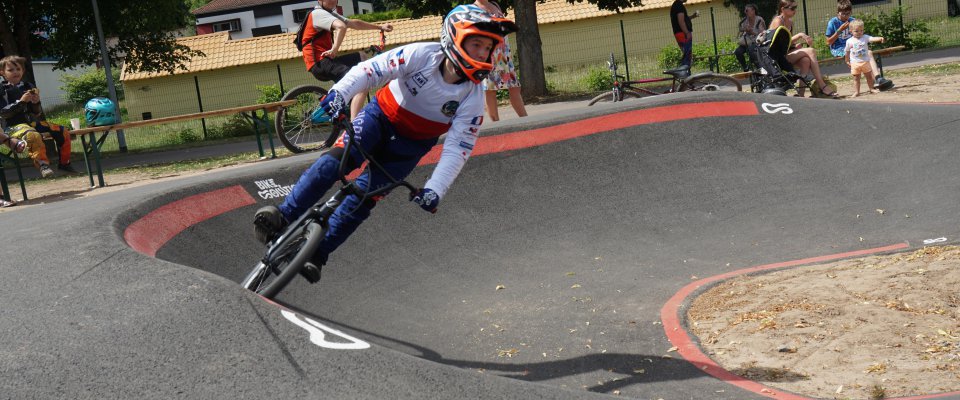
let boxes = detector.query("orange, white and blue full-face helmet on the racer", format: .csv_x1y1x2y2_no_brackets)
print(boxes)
440,5,517,83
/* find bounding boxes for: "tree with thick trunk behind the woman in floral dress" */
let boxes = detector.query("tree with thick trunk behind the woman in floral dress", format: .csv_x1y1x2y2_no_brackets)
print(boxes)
397,0,644,97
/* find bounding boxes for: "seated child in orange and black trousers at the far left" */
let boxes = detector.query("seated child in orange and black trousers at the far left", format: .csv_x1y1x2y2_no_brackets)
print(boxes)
0,56,77,173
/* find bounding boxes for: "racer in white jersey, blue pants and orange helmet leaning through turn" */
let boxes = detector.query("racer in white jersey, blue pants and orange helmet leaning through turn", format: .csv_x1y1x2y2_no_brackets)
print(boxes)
254,7,516,282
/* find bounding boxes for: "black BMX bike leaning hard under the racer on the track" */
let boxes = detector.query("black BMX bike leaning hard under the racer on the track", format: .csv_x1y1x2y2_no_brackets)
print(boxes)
241,116,418,299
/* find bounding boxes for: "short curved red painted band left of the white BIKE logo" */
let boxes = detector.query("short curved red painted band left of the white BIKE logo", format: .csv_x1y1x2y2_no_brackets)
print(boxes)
123,185,257,257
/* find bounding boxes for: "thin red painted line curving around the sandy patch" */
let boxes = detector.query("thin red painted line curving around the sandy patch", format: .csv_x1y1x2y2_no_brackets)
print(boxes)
660,243,960,400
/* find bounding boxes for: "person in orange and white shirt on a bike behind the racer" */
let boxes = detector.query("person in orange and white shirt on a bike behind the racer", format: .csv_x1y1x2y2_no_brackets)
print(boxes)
301,0,393,117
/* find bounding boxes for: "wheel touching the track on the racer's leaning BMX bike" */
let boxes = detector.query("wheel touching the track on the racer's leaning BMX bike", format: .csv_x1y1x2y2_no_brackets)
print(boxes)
241,221,325,299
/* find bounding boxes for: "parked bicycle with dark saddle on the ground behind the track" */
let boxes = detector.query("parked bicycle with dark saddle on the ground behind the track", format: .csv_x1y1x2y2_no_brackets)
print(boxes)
587,53,742,106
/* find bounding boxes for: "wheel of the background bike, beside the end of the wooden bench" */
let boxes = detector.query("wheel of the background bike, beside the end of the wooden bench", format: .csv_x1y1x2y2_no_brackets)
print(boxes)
274,85,338,153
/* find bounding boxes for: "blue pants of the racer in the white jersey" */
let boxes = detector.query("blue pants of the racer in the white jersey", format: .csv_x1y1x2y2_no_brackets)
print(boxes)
280,98,437,266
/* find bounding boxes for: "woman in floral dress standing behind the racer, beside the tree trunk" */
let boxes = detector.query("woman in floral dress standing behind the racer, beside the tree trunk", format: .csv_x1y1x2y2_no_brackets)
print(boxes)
473,0,527,121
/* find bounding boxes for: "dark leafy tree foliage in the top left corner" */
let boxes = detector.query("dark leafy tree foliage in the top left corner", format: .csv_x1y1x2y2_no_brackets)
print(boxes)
0,0,202,83
